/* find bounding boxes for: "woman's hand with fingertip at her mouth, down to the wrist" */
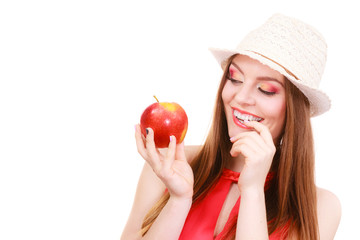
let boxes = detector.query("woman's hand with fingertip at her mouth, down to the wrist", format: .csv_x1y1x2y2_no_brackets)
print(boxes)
230,121,276,191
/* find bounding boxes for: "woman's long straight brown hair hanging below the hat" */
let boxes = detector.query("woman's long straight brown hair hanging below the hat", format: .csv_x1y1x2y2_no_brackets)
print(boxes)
141,56,318,239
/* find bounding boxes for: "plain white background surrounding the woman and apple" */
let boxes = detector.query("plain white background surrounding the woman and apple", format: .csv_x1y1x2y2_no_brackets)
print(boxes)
0,0,360,239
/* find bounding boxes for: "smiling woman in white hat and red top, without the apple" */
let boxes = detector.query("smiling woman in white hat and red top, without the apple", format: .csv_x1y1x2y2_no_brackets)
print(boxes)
122,14,341,240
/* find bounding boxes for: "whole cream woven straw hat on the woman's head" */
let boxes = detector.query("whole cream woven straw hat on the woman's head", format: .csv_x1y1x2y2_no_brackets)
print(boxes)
210,14,331,116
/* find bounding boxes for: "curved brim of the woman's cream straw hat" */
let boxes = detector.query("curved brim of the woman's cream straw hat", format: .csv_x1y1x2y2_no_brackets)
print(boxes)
209,48,331,117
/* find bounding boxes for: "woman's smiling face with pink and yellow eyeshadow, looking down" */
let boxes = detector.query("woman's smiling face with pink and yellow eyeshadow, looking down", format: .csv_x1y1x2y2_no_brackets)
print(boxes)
222,55,286,142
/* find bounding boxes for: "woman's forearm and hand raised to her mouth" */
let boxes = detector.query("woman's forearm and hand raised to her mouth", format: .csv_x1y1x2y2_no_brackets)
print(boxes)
230,122,276,240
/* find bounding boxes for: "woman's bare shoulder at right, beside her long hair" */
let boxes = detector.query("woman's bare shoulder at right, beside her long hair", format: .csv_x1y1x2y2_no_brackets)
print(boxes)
317,188,341,239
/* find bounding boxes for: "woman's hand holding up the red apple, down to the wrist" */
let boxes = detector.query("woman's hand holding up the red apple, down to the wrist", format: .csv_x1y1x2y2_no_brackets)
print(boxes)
135,125,194,199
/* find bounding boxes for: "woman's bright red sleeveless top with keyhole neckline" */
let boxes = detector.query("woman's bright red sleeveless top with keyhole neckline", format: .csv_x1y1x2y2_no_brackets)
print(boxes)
179,169,286,240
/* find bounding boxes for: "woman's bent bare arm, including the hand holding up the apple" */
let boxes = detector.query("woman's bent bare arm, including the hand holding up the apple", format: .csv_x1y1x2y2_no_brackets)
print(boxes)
121,126,195,240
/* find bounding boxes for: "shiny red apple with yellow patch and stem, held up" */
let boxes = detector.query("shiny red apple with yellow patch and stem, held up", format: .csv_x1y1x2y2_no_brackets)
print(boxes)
140,96,188,148
